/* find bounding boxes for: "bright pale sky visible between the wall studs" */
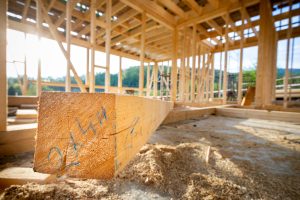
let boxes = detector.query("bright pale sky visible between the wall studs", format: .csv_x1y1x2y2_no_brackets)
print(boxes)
7,29,300,79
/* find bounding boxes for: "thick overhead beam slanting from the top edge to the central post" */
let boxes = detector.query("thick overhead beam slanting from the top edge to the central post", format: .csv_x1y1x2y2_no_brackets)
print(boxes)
121,0,176,30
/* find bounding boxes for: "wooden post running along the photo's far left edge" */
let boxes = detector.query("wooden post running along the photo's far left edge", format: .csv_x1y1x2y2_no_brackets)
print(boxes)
0,0,7,131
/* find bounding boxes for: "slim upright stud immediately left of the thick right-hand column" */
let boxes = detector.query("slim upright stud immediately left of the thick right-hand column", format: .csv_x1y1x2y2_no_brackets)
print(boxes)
237,8,245,104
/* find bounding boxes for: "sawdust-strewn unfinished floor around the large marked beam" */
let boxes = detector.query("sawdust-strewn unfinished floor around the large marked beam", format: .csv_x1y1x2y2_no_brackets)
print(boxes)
1,116,300,199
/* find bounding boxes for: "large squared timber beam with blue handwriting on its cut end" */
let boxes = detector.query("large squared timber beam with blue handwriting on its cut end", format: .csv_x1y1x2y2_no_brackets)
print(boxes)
34,92,173,179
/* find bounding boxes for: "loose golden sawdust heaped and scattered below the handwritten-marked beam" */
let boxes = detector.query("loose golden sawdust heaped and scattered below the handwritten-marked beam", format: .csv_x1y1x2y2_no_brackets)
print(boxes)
2,143,300,199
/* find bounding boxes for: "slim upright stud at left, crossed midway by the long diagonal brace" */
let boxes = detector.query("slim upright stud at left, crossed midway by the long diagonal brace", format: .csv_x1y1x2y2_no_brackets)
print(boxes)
65,0,72,92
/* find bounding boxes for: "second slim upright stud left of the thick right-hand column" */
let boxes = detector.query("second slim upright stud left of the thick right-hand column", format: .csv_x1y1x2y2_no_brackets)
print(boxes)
223,12,229,104
